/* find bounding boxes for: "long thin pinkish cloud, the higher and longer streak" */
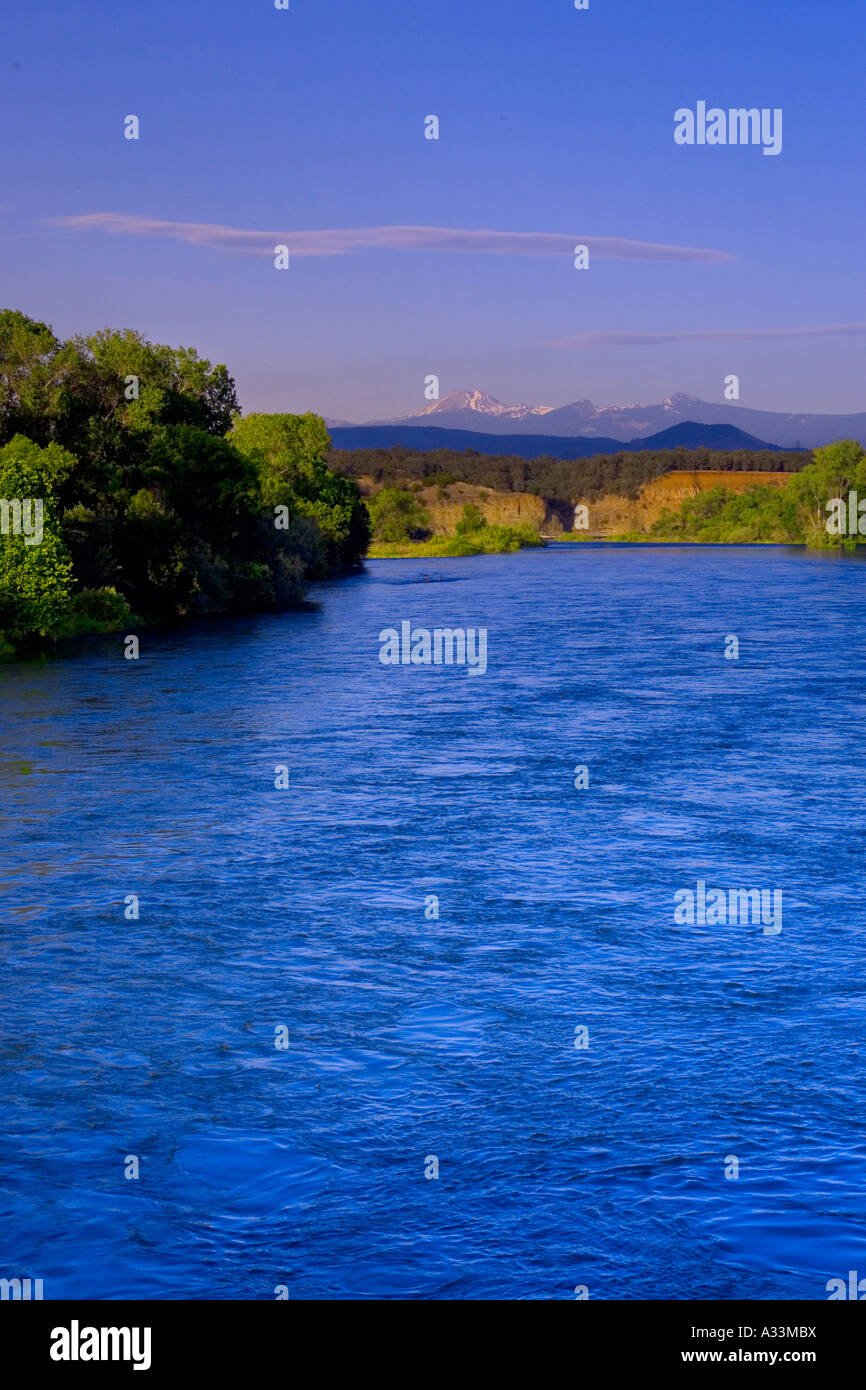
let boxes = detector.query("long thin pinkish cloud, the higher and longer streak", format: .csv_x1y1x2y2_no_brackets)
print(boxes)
49,213,735,264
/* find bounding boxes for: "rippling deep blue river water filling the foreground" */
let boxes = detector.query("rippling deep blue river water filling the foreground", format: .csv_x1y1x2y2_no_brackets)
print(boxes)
0,543,866,1300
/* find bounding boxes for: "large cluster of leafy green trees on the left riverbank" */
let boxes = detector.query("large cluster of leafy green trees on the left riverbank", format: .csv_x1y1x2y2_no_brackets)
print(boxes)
0,310,370,653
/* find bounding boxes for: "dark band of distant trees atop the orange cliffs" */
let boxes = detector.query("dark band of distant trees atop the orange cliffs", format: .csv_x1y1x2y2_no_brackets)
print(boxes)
328,445,809,500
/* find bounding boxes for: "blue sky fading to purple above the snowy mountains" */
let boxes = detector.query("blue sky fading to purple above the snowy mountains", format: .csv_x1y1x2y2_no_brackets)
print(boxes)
0,0,866,420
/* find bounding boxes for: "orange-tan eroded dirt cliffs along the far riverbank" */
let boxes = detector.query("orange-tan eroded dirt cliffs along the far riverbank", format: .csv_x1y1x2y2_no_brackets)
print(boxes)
359,468,791,538
